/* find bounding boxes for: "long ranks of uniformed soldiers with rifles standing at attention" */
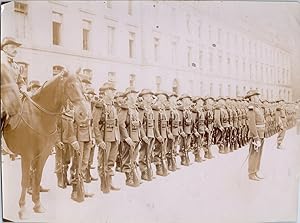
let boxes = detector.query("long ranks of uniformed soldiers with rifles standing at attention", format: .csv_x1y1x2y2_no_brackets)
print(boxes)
48,75,295,201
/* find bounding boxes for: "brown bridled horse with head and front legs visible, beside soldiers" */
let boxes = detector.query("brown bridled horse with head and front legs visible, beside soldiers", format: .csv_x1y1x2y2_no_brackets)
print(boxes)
3,71,87,219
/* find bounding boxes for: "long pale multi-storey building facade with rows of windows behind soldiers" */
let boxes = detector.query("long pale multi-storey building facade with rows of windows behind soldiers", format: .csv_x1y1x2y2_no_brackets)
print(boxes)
1,1,292,100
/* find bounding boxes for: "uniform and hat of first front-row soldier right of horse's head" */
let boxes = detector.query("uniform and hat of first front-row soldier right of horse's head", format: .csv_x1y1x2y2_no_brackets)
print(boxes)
93,83,120,193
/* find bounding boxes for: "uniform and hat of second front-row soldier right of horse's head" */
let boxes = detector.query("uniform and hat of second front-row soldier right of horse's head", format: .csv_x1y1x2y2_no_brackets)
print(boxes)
119,88,141,187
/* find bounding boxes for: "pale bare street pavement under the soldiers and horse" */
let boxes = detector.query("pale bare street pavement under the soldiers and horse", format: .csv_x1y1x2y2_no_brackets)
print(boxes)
2,128,300,223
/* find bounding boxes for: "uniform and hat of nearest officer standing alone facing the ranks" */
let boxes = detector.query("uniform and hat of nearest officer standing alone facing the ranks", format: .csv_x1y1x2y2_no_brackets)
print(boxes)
246,90,265,180
